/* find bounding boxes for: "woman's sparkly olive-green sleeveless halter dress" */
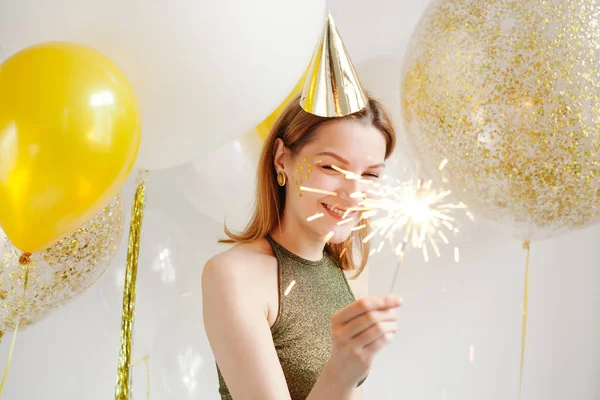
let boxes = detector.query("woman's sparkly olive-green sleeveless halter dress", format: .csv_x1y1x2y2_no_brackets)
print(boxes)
217,235,362,400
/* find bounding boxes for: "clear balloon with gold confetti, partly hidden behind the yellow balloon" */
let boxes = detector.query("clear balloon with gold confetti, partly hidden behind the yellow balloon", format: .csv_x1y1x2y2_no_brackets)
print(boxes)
0,195,123,333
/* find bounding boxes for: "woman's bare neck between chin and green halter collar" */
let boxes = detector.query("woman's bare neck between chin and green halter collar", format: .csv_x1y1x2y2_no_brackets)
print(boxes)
270,211,325,261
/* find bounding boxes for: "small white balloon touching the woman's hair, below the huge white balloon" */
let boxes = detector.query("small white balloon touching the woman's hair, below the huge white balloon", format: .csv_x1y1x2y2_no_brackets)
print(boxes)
177,130,262,230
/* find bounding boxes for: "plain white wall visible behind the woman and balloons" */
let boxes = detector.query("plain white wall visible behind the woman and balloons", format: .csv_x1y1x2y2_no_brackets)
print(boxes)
0,0,600,400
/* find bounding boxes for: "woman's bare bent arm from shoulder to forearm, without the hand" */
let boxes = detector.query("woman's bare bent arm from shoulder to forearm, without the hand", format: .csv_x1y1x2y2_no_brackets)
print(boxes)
202,253,355,400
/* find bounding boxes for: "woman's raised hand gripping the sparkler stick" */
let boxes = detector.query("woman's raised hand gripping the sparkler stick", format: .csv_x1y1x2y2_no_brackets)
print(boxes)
325,295,402,388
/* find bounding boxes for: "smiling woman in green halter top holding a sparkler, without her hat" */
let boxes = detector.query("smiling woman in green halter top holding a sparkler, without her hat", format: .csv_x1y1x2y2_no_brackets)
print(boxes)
202,94,401,400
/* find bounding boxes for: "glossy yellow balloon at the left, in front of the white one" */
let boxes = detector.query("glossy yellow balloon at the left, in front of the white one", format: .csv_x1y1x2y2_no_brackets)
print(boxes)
0,43,140,252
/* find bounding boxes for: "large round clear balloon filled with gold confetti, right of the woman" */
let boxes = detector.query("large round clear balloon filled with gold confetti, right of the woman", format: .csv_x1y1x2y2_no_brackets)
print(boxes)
401,0,600,240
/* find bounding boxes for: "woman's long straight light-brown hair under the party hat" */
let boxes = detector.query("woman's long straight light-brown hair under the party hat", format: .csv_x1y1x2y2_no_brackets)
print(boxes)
219,96,396,277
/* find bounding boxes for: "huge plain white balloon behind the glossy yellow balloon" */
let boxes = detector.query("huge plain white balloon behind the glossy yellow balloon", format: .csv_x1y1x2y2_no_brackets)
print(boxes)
0,0,325,169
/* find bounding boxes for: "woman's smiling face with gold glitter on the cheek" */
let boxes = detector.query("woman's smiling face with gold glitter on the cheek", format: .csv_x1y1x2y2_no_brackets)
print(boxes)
275,119,386,243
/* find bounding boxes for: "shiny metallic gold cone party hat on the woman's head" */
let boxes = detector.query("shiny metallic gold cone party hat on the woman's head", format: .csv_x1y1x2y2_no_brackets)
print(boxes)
300,13,369,117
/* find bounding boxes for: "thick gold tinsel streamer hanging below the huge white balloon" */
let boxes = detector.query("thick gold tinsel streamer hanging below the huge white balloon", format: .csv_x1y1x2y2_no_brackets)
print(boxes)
115,171,148,400
